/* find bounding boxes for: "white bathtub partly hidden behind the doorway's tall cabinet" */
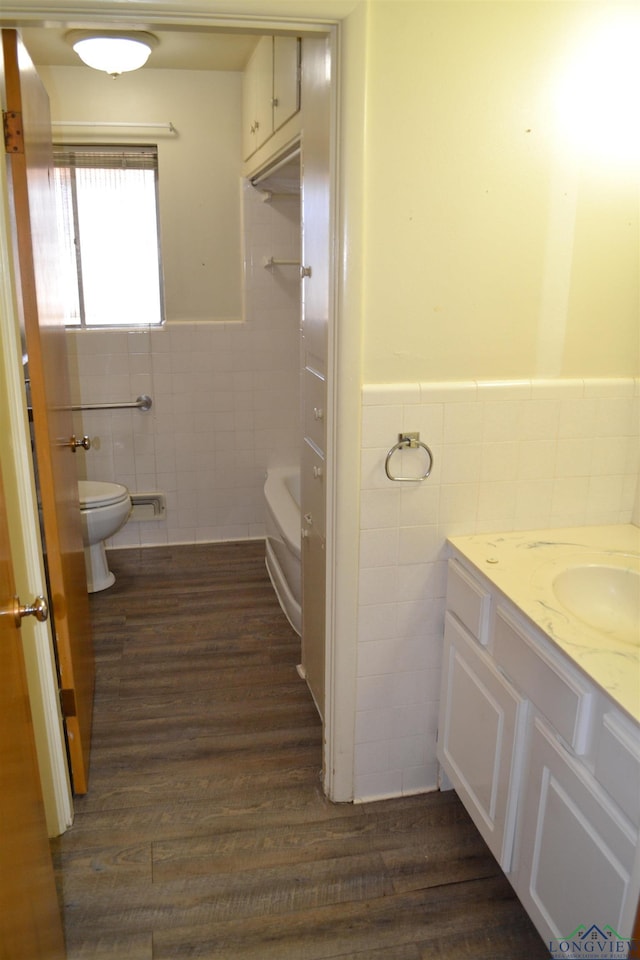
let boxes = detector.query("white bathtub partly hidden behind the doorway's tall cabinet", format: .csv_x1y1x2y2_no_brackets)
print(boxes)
264,467,302,634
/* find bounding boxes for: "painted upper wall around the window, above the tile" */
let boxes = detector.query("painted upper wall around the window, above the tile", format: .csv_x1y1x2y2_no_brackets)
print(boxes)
38,66,243,323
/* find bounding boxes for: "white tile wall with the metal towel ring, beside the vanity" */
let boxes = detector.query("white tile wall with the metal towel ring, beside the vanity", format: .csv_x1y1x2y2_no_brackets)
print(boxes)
354,380,640,800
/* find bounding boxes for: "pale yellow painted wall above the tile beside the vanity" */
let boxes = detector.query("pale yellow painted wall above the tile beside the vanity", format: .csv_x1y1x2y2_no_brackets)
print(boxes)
363,0,640,383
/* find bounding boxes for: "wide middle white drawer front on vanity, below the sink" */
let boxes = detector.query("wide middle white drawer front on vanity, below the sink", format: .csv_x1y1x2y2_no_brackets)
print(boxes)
492,607,593,754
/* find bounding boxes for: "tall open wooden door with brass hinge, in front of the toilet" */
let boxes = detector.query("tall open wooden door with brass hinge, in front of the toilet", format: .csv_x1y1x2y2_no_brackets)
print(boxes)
2,30,94,793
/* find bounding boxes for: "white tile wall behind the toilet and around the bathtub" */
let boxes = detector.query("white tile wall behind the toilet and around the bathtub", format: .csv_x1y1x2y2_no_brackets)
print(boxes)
69,183,300,546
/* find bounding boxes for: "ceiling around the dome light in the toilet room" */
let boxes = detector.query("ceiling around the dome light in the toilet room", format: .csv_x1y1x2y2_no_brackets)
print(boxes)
20,27,258,70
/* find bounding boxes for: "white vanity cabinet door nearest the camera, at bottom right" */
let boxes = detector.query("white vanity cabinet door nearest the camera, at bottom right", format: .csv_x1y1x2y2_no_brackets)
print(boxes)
512,716,637,956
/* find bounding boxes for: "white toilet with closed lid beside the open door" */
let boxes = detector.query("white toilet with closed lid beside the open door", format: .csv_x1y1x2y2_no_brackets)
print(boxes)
78,480,131,593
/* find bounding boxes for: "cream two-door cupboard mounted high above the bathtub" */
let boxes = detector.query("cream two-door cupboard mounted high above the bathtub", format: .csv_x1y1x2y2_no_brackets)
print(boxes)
242,37,300,160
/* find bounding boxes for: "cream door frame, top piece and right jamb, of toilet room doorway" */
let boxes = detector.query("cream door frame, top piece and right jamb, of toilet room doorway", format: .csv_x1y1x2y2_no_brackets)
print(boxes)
0,0,360,802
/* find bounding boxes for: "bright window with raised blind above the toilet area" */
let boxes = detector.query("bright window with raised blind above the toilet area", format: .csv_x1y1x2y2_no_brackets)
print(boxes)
54,146,162,327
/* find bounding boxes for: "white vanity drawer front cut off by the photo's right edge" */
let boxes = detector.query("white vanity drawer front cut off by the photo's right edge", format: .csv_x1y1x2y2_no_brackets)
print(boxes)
594,713,640,827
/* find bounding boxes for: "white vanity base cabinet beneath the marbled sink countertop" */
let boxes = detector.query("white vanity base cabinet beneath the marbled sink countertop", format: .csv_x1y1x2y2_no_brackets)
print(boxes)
438,557,640,957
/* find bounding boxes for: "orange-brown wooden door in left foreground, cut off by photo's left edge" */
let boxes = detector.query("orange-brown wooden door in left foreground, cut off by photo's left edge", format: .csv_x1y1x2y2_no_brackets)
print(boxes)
0,454,66,960
